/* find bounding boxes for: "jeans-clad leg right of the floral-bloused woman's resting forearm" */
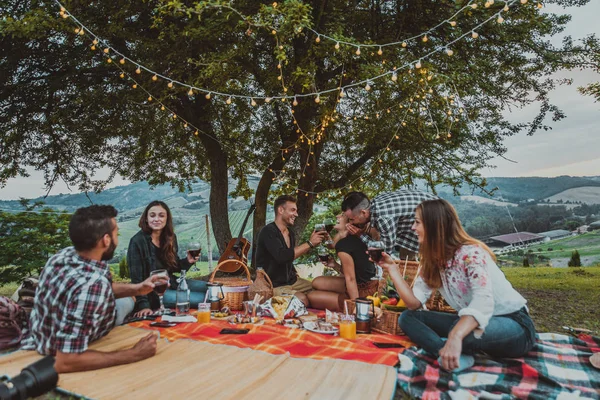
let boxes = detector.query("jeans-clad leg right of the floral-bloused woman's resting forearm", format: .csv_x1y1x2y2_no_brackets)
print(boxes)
463,316,534,358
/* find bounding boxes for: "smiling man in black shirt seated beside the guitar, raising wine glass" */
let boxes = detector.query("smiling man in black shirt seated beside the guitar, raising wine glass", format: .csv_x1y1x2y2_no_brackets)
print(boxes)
256,195,327,306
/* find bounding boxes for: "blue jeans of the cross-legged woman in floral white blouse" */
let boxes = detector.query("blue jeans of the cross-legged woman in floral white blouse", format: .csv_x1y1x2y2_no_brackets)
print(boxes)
398,307,535,358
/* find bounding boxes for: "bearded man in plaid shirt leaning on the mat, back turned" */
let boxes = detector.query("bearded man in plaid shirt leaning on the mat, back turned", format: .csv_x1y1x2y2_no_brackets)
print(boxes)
21,205,166,373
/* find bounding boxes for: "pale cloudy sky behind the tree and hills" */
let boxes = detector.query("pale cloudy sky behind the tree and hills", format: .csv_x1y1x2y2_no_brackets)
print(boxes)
0,0,600,200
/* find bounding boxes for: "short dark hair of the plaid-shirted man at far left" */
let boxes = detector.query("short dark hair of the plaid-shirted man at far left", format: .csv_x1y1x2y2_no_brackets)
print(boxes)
69,205,118,251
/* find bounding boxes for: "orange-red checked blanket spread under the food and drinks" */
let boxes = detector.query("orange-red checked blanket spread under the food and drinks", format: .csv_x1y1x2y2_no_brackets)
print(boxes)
129,319,413,366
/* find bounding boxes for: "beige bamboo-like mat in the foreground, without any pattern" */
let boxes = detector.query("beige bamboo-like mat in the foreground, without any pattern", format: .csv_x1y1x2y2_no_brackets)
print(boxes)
0,326,396,400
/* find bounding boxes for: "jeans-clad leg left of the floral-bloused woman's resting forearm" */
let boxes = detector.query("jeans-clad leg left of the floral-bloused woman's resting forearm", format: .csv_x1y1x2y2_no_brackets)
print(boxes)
398,310,460,357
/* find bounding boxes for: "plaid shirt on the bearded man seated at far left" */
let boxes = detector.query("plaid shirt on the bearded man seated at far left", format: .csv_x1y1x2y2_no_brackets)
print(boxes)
21,247,115,355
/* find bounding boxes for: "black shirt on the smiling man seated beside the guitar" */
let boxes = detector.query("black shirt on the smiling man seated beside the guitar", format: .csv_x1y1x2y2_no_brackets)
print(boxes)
256,222,298,287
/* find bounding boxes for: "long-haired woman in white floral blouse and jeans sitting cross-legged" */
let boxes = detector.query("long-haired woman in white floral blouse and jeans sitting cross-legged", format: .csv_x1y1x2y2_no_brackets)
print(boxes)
379,200,535,371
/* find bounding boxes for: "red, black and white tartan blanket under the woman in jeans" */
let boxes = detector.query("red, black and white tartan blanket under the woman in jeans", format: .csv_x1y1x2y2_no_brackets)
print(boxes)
398,333,600,400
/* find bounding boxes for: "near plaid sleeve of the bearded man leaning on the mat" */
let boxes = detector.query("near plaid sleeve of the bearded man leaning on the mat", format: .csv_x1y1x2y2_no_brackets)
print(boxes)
55,281,112,353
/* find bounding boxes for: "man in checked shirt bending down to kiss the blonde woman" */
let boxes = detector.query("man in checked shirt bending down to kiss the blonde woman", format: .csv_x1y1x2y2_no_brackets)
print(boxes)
342,190,437,254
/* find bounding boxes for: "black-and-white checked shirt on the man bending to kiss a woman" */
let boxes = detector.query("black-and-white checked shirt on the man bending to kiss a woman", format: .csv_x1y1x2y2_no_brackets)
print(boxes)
361,190,438,254
